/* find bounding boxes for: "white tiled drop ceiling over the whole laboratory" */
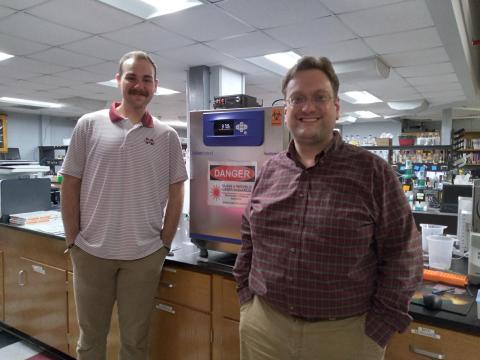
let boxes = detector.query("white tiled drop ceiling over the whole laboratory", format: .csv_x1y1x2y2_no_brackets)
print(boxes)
0,0,480,122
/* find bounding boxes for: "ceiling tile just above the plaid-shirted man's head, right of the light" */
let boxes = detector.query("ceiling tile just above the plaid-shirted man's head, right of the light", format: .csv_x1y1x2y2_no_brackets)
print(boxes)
296,39,375,62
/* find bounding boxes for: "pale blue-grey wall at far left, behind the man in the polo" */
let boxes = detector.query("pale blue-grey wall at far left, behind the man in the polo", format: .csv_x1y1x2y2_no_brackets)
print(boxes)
7,113,77,161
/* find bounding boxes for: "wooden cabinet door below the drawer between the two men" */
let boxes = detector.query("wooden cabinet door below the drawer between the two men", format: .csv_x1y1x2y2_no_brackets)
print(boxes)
149,299,211,360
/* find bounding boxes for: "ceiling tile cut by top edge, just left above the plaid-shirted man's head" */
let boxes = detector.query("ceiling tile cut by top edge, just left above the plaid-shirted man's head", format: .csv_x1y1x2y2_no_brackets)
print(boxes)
217,0,331,29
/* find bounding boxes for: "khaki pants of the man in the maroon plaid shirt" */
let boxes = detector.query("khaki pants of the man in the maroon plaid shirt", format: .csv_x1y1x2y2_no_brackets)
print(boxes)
240,296,385,360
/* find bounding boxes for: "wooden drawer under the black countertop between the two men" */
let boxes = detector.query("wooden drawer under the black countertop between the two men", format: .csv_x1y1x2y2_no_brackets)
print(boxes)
157,266,211,312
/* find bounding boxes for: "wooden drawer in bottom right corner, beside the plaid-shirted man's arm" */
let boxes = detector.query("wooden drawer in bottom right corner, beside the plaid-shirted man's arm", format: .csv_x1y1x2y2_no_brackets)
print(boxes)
385,322,480,360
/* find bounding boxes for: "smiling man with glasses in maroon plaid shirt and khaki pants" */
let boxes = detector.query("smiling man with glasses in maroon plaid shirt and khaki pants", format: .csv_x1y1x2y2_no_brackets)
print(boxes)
234,57,423,360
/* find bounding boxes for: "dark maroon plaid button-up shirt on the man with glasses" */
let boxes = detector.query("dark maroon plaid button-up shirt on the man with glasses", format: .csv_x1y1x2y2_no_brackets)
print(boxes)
234,133,423,345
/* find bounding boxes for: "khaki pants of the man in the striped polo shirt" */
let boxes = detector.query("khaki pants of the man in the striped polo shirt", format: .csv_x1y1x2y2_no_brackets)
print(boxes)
70,246,167,360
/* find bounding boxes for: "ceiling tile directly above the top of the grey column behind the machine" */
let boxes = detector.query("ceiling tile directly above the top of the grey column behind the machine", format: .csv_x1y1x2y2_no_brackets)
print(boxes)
159,44,231,68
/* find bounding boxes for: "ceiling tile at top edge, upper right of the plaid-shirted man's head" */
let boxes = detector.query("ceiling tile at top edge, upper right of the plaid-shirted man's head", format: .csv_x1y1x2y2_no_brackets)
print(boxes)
339,0,433,37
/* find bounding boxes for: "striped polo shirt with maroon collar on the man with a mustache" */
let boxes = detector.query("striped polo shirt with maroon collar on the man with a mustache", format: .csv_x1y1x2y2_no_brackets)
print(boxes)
60,103,187,260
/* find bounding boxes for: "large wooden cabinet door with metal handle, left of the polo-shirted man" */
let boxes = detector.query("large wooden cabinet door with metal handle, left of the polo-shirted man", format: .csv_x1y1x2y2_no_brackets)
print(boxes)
5,258,68,353
